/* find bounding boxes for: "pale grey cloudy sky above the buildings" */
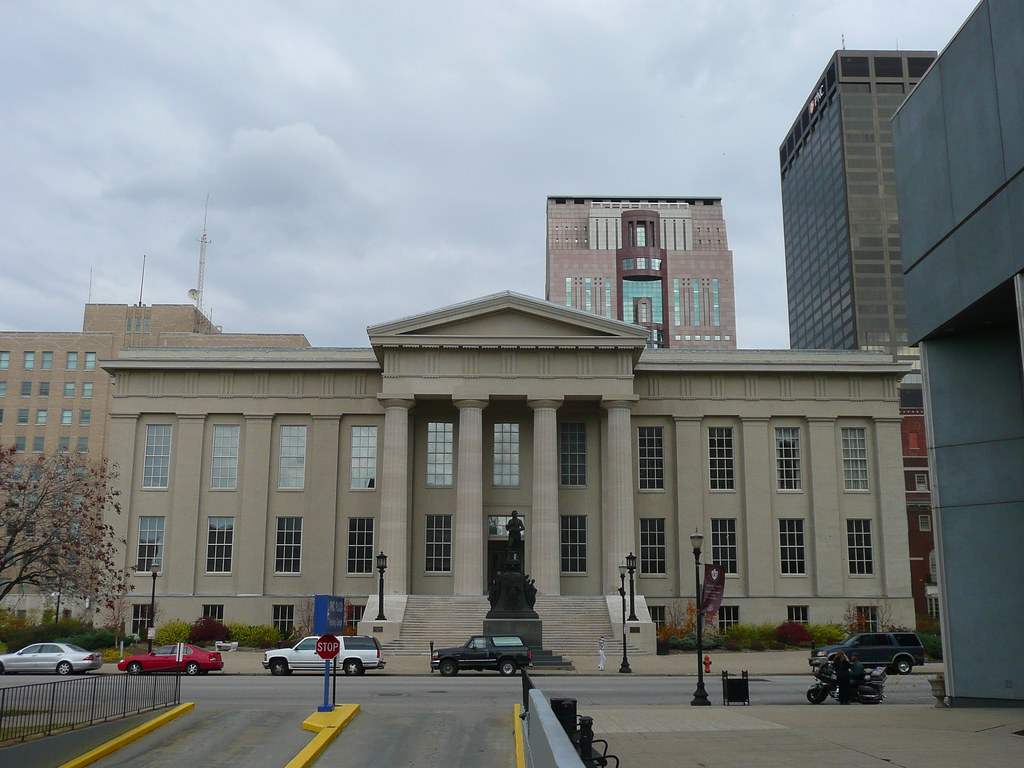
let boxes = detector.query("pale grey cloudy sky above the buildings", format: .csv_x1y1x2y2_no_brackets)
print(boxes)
0,0,976,348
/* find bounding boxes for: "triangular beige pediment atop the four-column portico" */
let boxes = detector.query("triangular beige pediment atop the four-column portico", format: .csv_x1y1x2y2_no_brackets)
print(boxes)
367,292,647,353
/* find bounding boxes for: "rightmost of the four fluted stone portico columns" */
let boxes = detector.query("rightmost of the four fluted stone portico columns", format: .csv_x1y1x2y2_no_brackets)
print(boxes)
601,399,637,594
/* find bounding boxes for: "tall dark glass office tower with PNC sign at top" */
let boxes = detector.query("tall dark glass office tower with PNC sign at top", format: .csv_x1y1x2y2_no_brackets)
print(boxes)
779,50,936,359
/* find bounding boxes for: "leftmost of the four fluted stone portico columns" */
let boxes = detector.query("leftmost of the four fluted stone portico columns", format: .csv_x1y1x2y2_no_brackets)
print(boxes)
377,395,416,595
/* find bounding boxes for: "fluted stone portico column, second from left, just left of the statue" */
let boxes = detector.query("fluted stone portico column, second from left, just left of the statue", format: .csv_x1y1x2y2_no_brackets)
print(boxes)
453,399,487,595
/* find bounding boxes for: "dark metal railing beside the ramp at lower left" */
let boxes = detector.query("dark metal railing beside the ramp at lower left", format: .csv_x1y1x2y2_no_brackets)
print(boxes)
0,675,181,743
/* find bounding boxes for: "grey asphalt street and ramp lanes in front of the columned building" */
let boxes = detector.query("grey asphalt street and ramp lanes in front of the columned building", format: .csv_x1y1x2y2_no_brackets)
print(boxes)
0,673,934,768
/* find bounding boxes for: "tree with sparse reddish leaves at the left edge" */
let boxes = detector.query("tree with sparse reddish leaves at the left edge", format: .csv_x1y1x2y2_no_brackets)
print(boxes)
0,446,131,605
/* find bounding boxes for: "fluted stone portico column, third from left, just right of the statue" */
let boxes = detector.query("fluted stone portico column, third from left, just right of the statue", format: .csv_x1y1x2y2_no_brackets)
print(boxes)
526,400,561,595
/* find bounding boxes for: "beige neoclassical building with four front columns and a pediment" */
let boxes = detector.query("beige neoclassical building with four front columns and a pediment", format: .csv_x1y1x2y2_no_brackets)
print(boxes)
101,293,913,644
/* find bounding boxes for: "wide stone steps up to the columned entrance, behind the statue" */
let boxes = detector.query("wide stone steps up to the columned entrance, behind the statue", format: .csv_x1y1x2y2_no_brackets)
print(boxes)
384,595,639,669
